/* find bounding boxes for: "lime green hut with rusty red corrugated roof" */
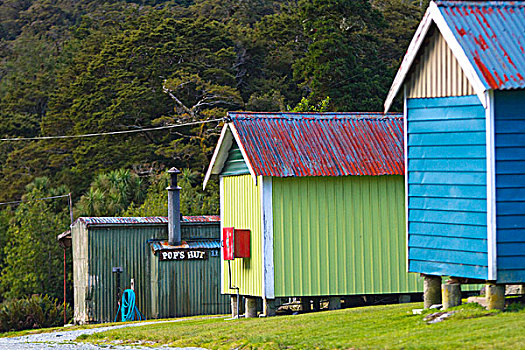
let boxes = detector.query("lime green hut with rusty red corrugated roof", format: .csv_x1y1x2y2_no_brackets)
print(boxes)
204,112,422,314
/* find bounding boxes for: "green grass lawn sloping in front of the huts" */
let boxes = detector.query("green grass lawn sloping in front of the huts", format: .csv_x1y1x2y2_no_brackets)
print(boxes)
83,303,525,349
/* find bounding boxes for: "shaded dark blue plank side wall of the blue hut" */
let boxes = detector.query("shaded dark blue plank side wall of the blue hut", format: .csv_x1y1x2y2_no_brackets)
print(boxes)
494,90,525,283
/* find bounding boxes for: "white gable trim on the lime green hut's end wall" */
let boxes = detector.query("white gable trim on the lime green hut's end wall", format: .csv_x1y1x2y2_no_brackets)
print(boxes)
202,123,257,189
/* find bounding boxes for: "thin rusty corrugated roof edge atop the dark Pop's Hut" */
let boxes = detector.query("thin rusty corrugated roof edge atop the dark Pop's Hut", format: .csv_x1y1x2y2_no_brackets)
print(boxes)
75,215,221,226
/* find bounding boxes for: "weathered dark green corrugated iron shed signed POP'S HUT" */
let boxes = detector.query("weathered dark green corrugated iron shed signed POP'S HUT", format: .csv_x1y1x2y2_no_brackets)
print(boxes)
71,217,229,323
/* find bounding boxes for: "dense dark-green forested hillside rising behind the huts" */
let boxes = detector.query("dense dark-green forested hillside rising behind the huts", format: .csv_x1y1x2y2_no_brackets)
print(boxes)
0,0,428,300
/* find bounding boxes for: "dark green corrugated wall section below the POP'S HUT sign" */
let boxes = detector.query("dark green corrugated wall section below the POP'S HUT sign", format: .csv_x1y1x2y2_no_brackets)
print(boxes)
151,253,230,318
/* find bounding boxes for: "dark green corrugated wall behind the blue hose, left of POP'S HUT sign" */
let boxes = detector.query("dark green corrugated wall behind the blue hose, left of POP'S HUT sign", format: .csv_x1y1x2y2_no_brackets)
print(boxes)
86,226,166,322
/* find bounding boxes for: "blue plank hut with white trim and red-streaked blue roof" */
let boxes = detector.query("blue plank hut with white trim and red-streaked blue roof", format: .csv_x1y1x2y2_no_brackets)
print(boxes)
385,1,525,284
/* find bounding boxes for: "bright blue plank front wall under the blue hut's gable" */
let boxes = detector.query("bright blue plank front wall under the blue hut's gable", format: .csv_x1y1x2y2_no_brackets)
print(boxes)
407,95,488,279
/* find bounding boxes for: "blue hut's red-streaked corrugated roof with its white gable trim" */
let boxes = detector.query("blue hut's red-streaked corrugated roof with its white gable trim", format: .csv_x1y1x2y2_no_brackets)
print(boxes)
385,1,525,111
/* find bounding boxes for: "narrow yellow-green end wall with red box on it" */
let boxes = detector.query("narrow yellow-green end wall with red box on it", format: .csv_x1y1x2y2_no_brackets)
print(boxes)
221,175,263,296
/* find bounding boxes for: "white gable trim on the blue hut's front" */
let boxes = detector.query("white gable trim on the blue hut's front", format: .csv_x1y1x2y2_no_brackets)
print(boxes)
384,2,487,113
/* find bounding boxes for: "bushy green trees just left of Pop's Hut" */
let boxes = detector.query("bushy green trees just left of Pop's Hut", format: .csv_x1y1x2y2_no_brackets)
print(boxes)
0,177,71,299
